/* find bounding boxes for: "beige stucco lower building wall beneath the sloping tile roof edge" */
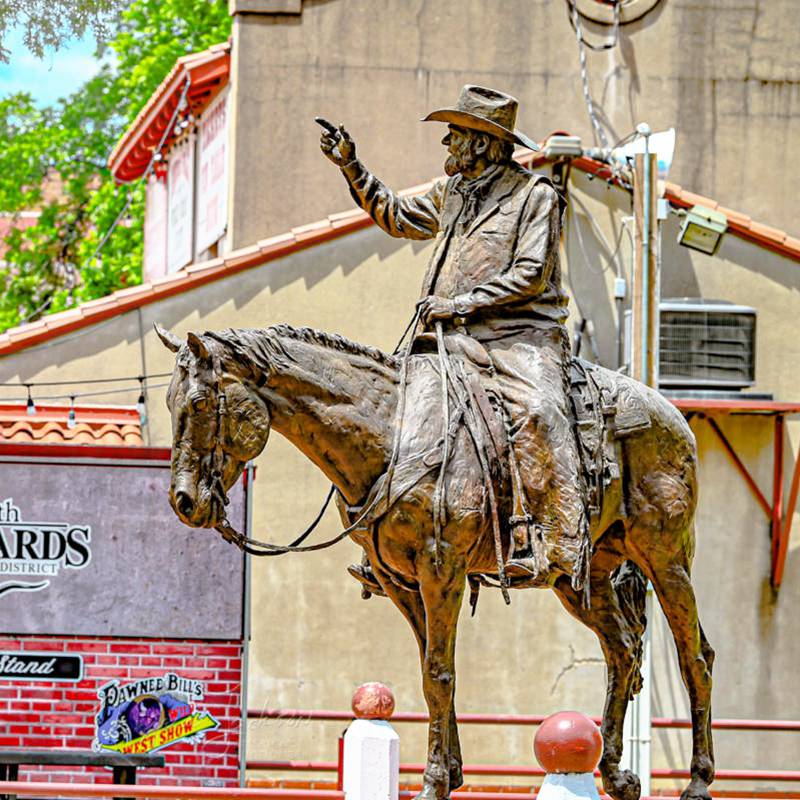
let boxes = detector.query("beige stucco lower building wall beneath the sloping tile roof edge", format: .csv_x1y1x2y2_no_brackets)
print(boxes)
0,171,800,780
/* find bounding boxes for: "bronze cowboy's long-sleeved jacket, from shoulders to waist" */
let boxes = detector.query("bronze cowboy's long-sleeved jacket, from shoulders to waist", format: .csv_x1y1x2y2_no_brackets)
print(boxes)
342,160,567,340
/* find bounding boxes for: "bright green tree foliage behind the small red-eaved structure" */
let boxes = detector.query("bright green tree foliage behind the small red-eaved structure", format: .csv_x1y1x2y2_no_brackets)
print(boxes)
0,0,230,330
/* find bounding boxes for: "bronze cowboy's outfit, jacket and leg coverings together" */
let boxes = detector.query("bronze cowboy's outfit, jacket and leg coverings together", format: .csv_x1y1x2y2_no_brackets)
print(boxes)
342,161,588,568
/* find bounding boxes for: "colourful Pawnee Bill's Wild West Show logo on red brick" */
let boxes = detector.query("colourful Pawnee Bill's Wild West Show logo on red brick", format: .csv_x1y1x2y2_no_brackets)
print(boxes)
93,672,219,753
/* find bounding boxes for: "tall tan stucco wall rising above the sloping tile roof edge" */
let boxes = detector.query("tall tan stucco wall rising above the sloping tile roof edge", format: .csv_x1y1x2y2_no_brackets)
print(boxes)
229,0,800,248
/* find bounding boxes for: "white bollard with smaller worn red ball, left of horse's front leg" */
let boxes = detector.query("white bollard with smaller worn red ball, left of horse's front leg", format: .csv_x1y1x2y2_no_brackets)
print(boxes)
342,683,400,800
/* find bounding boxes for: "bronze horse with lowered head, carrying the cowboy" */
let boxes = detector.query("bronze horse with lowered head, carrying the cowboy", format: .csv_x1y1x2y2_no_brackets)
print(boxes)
158,325,714,800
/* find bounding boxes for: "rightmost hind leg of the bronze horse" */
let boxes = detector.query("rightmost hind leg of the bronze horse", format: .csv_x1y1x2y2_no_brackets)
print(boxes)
643,548,714,800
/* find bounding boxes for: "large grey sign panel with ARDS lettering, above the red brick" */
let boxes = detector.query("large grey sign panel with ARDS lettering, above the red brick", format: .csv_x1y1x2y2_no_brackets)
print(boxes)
0,460,246,640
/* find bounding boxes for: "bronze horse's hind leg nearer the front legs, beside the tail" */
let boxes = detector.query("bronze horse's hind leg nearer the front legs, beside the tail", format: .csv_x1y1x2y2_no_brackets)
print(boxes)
554,535,646,800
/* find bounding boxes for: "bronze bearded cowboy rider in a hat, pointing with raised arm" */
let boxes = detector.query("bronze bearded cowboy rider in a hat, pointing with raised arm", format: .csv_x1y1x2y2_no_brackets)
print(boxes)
320,86,589,592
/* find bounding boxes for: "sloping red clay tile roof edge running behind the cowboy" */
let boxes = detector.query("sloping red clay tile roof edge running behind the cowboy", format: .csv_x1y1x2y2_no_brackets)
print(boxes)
0,145,800,357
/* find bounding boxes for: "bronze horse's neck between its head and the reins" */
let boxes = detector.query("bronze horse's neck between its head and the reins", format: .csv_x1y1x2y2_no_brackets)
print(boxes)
261,337,397,504
